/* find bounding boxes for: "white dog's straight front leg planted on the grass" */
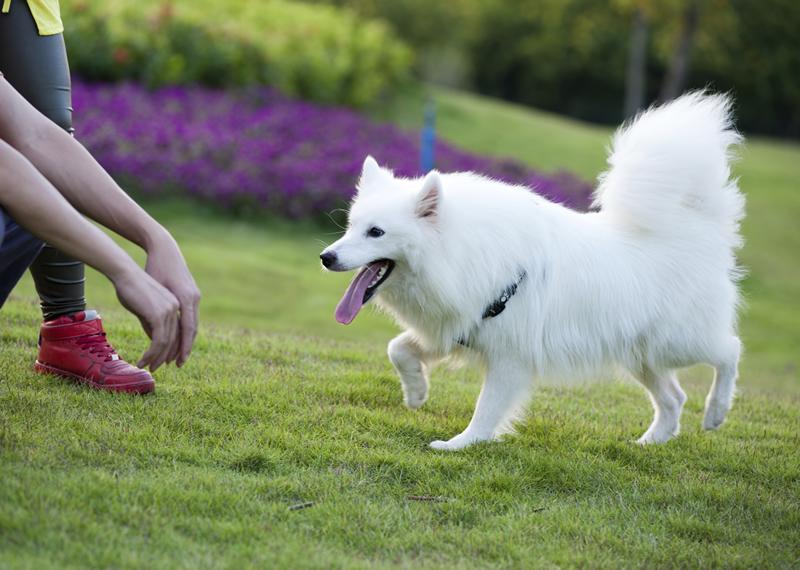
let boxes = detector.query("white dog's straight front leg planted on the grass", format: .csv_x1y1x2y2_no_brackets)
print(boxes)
431,359,533,451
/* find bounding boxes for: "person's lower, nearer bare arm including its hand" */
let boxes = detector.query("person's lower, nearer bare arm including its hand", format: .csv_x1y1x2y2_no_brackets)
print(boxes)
0,140,180,370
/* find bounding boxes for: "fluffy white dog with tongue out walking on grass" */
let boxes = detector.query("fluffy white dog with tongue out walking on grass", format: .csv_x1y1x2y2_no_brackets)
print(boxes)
320,93,744,450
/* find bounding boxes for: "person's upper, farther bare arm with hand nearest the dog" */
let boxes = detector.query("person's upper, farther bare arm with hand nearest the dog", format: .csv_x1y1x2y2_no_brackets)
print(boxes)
0,75,200,366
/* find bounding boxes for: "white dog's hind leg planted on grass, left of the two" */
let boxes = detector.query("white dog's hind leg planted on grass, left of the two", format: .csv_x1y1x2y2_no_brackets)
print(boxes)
634,365,686,445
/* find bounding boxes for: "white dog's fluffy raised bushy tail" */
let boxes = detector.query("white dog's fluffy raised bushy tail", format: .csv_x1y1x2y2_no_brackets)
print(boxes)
594,91,744,248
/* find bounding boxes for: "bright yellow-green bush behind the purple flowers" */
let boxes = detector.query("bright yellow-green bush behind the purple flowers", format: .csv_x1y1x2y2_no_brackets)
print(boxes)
61,0,412,106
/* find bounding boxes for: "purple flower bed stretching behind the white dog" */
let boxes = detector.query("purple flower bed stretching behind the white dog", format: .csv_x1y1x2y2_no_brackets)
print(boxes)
73,82,590,217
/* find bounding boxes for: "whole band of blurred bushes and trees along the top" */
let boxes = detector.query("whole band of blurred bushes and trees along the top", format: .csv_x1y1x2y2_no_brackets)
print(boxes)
62,0,800,136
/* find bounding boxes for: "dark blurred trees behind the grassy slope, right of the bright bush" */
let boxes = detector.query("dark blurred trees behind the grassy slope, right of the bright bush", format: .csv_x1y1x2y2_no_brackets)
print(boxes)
305,0,800,136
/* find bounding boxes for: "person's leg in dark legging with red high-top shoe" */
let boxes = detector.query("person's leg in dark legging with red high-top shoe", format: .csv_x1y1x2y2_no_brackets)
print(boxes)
0,1,155,393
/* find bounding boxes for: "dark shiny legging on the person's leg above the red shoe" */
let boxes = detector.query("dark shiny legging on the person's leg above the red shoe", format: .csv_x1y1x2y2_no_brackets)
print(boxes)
0,0,86,320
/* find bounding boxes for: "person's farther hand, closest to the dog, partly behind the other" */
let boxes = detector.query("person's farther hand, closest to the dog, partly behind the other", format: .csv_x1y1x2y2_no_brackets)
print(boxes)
145,230,200,367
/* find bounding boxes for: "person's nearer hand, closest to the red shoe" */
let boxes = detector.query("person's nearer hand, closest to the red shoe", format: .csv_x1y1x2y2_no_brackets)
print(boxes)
112,264,181,371
